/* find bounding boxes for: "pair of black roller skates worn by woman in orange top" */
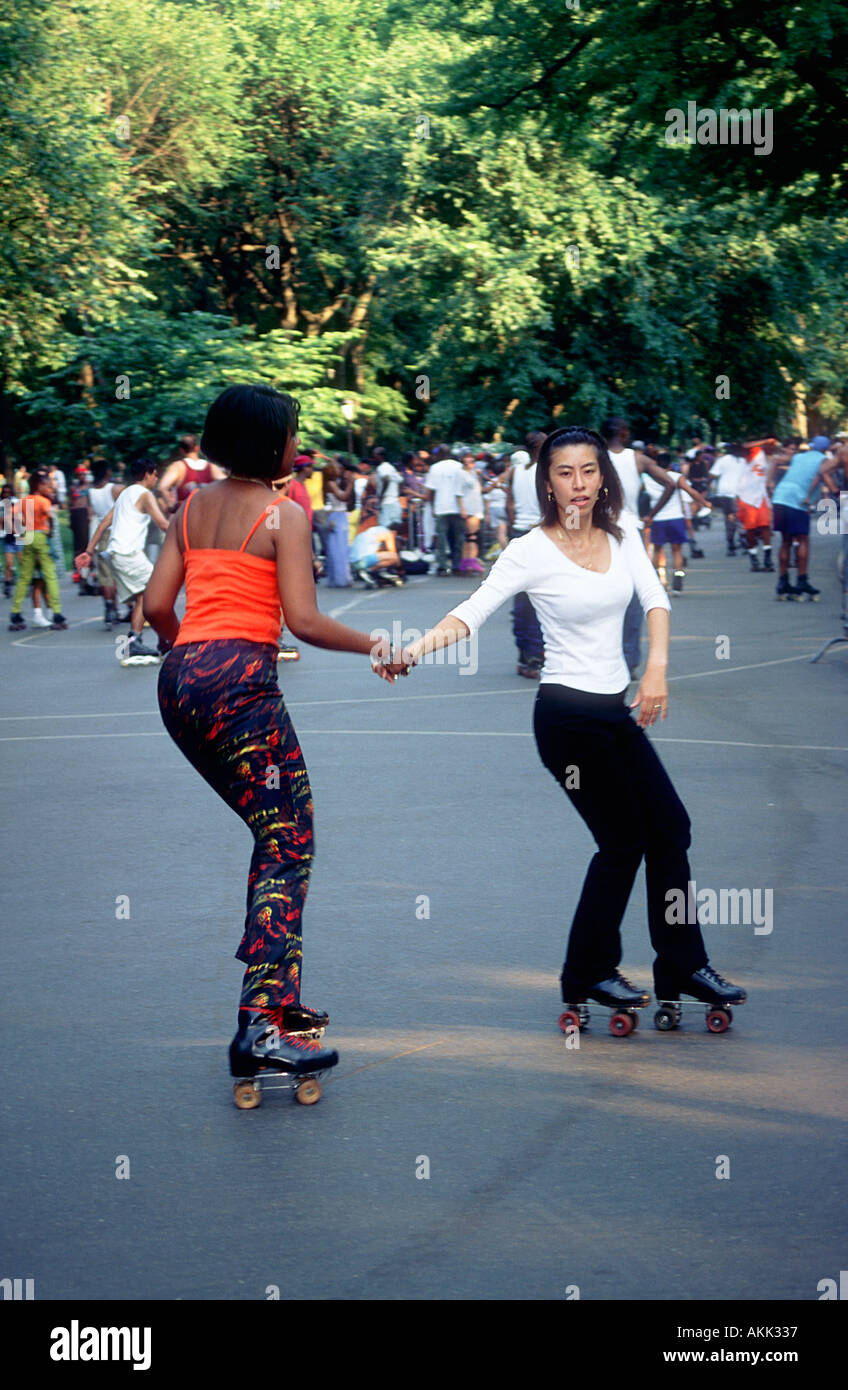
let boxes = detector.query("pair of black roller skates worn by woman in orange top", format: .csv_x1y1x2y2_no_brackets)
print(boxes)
229,1006,339,1111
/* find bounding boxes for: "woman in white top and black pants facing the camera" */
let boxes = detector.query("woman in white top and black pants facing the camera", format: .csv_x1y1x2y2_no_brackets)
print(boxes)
398,427,745,1028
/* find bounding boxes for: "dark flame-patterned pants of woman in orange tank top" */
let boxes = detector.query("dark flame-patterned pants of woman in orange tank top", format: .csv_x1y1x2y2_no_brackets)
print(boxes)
158,638,314,1013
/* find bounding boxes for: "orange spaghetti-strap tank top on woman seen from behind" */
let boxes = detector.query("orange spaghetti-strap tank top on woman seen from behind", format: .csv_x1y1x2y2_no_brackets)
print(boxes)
174,492,284,646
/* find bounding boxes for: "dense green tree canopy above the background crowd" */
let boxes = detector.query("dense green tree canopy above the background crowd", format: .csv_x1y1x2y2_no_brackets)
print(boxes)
0,0,848,463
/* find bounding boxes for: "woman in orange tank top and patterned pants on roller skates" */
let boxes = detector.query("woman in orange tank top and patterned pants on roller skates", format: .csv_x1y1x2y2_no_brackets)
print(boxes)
145,385,400,1105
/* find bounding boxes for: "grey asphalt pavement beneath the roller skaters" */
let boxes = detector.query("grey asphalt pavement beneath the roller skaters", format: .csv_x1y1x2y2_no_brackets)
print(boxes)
0,524,848,1300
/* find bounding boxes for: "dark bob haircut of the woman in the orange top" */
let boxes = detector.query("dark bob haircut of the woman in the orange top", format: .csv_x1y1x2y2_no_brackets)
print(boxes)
200,386,300,478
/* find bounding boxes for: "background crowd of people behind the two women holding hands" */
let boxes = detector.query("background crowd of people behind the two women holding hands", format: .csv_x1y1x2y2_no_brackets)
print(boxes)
0,418,848,667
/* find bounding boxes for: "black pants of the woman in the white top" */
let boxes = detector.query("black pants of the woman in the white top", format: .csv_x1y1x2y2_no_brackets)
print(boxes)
534,684,708,1004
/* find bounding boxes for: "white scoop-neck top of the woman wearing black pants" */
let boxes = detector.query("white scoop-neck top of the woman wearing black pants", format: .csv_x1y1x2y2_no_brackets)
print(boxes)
449,513,671,695
